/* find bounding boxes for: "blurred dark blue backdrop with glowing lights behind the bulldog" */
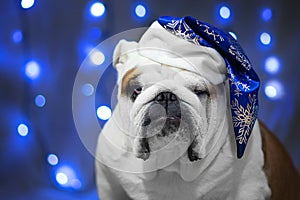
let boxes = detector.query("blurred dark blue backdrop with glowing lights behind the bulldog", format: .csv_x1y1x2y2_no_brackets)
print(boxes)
0,0,300,200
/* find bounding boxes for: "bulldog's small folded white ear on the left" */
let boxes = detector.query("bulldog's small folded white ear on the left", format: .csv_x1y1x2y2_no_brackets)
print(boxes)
113,40,138,73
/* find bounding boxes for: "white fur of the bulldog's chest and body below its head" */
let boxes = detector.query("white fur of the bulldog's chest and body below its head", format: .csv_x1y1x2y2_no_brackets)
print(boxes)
96,77,270,200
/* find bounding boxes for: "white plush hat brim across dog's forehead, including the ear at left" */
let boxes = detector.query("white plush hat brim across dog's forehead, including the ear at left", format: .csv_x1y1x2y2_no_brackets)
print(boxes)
114,21,226,85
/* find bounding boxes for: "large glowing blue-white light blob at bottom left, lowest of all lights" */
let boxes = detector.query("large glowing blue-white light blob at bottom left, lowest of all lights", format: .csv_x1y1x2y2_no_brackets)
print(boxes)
55,165,82,190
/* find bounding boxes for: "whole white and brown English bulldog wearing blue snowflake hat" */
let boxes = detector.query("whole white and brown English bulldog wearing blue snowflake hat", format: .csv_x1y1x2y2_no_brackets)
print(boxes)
96,17,300,200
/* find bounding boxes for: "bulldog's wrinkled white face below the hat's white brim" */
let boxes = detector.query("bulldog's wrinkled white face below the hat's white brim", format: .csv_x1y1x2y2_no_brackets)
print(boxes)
117,62,226,161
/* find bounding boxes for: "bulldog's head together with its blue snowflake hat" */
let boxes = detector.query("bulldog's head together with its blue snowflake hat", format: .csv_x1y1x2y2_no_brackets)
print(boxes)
109,18,259,166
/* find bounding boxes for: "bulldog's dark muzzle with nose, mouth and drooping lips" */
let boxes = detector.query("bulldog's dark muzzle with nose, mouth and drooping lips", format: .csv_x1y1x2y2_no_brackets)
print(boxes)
134,92,199,161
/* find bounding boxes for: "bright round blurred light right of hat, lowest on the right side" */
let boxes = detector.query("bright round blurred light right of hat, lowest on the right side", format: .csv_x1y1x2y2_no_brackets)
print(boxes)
264,80,284,100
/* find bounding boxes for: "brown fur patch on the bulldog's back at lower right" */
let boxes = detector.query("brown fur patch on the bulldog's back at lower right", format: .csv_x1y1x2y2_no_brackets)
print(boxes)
259,121,300,200
